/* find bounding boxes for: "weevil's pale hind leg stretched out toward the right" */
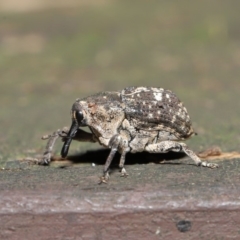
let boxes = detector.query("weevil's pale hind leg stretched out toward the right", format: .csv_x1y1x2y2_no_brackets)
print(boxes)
145,141,218,168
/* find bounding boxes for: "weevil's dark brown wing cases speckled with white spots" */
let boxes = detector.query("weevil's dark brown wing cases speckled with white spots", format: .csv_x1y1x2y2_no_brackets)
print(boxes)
121,87,194,139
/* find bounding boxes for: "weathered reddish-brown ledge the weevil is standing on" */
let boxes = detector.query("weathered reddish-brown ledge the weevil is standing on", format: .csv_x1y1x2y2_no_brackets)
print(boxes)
0,151,240,239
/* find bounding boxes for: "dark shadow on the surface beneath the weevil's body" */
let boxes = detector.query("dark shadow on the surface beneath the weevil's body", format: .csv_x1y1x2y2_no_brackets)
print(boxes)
67,149,186,166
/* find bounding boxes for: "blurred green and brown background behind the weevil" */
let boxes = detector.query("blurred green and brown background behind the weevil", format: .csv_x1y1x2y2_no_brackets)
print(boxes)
0,0,240,165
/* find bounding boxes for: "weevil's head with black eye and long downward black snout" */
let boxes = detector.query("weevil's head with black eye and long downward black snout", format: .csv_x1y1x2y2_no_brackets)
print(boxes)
61,101,86,158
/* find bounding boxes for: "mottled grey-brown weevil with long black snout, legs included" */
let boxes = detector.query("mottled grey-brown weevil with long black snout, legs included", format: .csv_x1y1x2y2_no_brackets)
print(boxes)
41,87,218,182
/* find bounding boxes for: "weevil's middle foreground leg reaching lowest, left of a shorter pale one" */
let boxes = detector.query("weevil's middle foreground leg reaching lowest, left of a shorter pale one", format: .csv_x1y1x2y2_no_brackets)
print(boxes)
99,135,121,184
